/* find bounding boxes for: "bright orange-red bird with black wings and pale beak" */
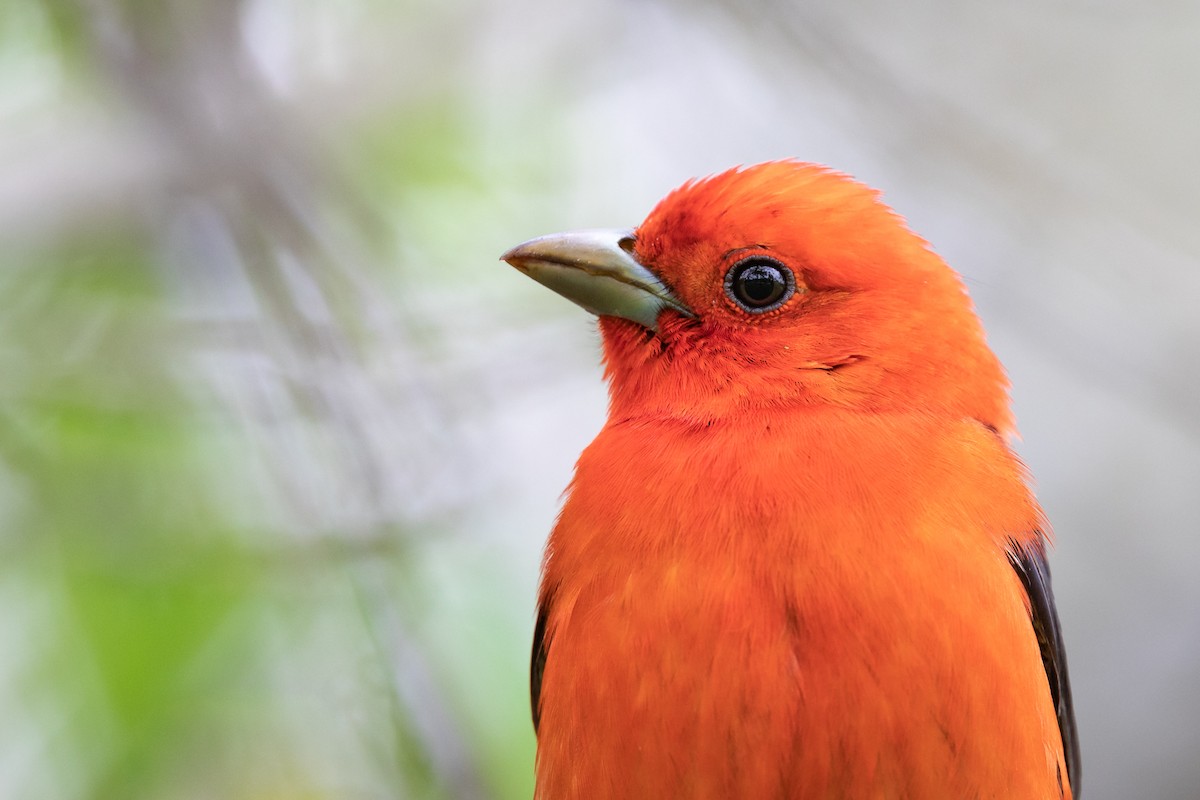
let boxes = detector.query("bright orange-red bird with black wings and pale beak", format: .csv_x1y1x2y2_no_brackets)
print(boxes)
503,161,1079,800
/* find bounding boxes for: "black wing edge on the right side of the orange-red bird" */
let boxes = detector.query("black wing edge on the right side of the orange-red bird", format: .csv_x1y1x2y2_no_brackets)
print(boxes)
1008,531,1081,800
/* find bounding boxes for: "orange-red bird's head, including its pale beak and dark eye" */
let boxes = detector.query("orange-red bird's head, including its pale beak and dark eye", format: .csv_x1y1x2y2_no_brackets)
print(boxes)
502,161,1012,434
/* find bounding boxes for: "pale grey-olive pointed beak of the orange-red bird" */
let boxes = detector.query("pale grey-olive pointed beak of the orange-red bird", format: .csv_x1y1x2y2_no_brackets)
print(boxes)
500,230,696,331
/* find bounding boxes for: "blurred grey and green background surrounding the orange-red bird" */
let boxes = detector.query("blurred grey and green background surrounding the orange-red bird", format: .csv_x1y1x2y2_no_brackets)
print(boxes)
0,0,1200,800
